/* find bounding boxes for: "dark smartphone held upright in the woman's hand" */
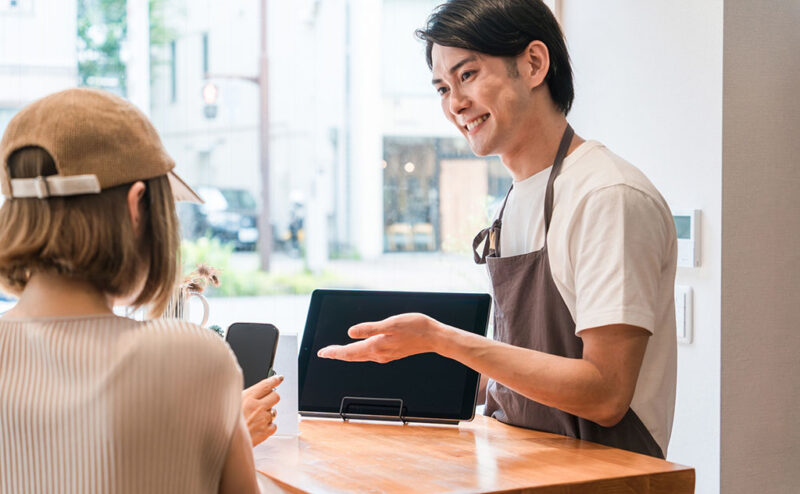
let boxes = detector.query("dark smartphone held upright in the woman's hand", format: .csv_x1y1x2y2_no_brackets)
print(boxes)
225,322,279,388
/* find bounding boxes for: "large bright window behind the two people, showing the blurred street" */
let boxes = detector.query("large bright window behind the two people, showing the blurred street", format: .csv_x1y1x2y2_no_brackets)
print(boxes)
0,0,510,332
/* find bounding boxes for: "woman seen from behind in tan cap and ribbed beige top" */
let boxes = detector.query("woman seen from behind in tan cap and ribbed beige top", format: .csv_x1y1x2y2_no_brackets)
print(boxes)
0,89,279,492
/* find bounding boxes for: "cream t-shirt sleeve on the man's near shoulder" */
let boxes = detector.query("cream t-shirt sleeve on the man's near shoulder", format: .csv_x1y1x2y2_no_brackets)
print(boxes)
568,185,670,334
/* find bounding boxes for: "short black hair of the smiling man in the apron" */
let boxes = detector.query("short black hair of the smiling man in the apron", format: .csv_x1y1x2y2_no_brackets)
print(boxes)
416,0,575,115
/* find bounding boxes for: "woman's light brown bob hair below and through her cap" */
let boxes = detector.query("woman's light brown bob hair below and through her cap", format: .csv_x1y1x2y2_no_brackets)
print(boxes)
0,147,180,317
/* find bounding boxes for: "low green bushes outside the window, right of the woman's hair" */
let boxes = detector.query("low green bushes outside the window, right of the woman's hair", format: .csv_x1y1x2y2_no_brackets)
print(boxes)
181,237,338,297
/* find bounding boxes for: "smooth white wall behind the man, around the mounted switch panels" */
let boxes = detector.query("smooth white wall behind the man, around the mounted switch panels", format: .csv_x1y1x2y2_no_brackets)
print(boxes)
562,0,723,493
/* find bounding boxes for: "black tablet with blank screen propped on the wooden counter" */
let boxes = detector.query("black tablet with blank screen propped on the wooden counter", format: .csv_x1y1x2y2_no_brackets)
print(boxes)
299,290,490,420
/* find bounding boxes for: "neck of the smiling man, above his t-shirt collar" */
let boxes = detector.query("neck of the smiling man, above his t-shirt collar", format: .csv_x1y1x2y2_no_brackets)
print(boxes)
500,112,585,182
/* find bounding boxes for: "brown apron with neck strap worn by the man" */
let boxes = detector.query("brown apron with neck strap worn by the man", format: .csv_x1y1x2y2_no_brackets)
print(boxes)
473,125,664,458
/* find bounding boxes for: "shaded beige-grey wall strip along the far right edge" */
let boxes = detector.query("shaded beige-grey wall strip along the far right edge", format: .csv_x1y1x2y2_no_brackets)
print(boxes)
721,0,800,494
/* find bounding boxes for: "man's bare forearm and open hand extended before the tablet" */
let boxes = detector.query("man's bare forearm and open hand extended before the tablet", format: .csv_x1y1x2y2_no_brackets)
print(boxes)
319,314,649,427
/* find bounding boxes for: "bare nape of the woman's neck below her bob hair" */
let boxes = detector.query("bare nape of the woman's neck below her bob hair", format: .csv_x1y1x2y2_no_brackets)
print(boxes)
4,273,113,319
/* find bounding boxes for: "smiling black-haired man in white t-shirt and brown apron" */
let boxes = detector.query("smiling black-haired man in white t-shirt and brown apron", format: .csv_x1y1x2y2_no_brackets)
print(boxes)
319,0,676,458
